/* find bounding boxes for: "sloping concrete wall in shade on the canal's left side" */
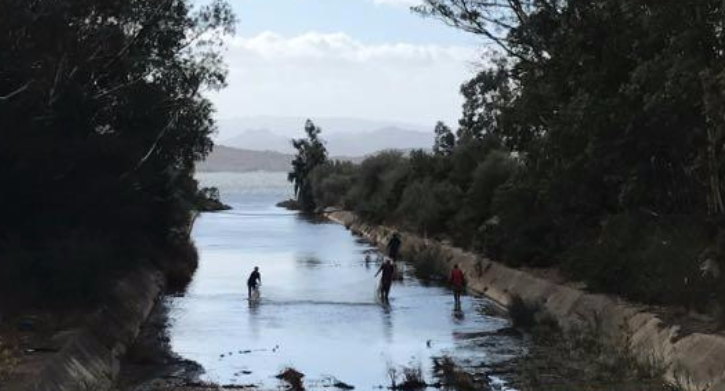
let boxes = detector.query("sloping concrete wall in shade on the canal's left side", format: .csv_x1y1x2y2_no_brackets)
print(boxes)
19,269,165,391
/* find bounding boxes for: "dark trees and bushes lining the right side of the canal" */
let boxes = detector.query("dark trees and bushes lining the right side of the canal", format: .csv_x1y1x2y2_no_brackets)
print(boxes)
296,0,725,316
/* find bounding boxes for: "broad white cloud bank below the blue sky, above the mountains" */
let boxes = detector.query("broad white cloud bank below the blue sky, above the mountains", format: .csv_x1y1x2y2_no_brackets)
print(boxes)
208,32,477,128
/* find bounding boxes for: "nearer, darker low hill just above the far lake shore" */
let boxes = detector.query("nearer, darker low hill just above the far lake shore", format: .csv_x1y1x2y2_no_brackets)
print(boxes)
196,145,363,172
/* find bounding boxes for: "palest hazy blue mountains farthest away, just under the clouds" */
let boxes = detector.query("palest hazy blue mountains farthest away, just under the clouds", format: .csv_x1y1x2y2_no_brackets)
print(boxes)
219,127,434,156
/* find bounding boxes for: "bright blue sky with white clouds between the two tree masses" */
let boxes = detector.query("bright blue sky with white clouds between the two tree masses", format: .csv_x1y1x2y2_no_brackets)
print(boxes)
201,0,481,126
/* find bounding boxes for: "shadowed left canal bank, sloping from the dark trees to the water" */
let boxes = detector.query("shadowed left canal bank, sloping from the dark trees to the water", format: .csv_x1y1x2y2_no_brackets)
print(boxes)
0,212,204,391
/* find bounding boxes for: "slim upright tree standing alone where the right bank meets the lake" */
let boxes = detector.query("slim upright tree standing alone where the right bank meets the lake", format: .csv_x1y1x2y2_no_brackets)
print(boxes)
287,120,327,212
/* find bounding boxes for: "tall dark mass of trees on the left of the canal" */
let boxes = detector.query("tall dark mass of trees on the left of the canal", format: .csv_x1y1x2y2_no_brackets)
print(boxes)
0,0,234,306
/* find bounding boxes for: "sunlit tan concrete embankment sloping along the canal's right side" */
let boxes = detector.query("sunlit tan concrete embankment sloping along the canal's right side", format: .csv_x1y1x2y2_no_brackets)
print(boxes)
327,211,725,391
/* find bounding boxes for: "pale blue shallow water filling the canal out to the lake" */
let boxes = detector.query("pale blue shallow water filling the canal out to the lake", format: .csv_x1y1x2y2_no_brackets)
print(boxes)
169,173,523,390
